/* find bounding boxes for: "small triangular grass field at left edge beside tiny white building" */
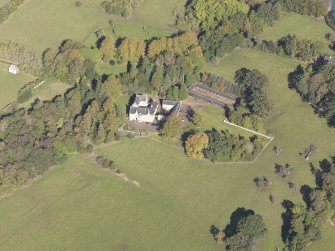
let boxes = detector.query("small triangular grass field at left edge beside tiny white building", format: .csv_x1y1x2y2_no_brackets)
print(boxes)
0,64,35,109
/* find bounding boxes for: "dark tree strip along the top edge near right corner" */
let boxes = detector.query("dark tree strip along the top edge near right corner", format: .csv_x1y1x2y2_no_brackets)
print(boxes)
278,0,328,17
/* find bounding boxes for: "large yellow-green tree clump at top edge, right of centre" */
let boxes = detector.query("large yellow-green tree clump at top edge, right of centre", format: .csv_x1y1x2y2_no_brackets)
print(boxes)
175,0,281,60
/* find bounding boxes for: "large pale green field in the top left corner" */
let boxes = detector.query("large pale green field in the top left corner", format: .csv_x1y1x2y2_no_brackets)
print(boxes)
0,0,110,53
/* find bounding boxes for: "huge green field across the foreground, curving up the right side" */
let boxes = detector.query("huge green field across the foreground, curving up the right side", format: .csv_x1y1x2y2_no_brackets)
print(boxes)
0,49,335,251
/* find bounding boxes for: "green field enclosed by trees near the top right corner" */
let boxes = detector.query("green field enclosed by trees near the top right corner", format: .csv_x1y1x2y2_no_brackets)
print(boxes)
260,13,334,54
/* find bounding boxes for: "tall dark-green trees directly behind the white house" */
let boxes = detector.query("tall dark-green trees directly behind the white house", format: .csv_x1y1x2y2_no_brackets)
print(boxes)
120,52,199,97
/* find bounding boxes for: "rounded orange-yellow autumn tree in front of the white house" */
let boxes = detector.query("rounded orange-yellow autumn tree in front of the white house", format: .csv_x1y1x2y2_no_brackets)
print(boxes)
185,133,208,159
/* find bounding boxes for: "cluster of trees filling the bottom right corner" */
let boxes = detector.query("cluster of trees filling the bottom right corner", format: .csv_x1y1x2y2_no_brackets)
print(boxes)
283,157,335,251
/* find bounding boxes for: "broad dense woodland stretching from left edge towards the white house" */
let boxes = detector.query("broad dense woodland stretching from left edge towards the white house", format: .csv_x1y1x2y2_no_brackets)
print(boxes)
0,61,121,194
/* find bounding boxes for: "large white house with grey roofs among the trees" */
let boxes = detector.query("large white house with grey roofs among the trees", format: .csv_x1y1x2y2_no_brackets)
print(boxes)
129,95,158,123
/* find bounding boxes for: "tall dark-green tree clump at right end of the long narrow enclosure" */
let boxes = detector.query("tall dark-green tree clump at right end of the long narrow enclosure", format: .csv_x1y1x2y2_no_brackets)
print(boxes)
235,68,271,117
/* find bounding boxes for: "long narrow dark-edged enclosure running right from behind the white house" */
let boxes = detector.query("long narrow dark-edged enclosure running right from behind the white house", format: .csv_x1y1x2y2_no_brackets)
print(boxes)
188,84,238,107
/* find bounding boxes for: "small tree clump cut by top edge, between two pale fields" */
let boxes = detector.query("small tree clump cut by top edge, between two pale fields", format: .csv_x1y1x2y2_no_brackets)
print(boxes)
101,0,140,17
